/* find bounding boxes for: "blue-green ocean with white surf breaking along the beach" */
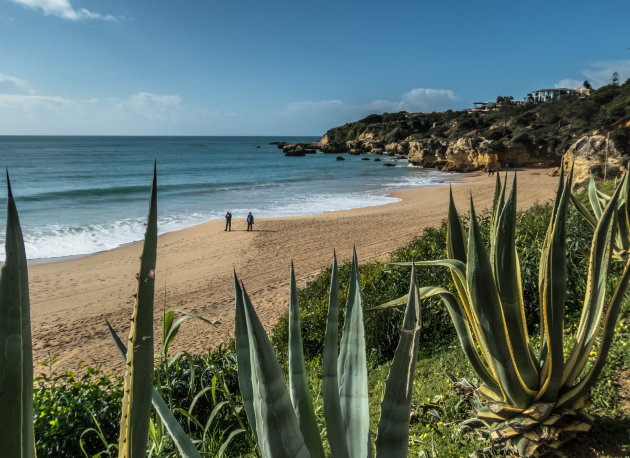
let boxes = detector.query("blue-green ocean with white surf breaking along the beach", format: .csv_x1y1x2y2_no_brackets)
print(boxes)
0,136,449,262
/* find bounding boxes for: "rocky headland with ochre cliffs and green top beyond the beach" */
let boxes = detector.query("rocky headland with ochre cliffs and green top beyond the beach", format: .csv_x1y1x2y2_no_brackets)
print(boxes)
278,80,630,181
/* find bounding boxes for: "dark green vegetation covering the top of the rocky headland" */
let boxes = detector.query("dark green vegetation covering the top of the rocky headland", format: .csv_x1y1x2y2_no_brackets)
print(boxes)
326,80,630,160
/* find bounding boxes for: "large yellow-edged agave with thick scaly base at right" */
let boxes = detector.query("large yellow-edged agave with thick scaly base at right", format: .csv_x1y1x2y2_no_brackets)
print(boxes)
378,172,630,456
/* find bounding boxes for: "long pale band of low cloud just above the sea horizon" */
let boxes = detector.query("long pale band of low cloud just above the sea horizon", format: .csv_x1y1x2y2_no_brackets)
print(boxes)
0,73,461,135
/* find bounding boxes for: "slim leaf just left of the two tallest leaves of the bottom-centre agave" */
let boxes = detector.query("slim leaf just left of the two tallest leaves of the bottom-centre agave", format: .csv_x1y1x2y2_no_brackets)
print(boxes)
289,263,324,458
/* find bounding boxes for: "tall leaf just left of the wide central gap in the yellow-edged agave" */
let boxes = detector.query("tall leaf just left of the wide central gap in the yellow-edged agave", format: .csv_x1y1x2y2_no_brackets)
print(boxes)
494,174,538,391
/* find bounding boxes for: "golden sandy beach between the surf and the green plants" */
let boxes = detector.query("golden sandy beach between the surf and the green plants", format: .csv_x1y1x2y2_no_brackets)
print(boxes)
29,169,558,374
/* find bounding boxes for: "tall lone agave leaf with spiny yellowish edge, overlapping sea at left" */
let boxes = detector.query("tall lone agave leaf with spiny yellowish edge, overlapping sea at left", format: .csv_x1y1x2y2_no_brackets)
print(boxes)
118,167,157,458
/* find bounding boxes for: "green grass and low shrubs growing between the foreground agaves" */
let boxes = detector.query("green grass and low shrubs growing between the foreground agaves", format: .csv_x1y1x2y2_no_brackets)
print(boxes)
34,184,630,457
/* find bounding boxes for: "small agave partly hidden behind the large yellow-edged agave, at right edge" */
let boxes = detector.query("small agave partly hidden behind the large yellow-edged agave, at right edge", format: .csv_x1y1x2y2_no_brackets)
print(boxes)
571,173,630,261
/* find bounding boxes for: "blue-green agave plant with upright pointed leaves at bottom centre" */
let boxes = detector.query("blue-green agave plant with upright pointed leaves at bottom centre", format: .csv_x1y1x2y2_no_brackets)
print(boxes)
234,253,421,458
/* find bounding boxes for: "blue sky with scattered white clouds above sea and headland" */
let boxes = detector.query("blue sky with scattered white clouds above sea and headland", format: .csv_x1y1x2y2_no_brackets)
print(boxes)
0,0,630,136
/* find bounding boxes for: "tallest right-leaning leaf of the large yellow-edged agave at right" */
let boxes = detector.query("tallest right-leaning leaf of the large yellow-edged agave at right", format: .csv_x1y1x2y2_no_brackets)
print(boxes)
562,179,621,385
